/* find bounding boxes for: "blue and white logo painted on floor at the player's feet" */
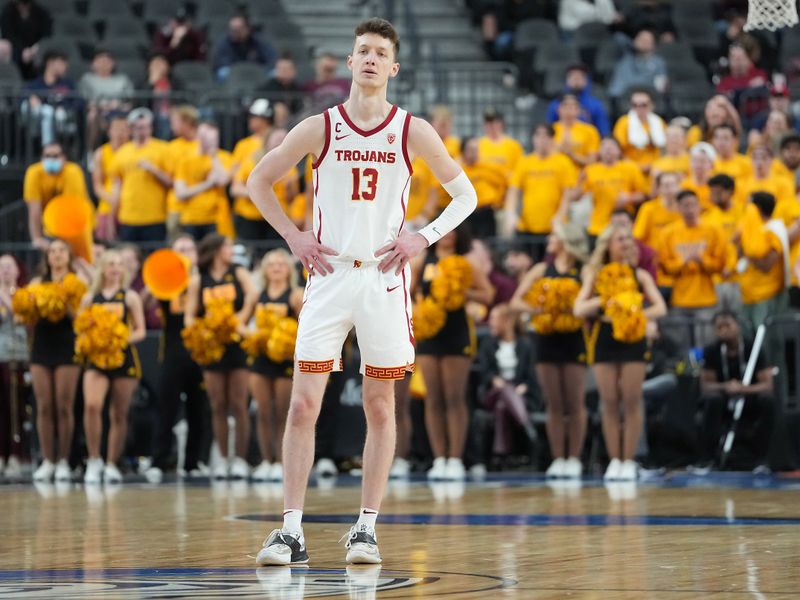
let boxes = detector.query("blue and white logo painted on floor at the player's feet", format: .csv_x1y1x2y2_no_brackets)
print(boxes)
0,565,516,600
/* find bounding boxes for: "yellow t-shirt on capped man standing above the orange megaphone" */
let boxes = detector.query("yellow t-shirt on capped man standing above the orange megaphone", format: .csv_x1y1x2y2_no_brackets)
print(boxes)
109,138,168,225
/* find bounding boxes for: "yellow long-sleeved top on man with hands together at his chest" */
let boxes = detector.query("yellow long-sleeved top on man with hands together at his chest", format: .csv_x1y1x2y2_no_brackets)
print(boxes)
658,220,728,308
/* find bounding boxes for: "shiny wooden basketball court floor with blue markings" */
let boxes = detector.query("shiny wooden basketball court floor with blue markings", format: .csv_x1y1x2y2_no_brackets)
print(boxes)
0,473,800,600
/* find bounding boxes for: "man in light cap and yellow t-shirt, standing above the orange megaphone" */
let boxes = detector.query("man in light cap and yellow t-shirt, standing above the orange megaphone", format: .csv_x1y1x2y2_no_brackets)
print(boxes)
109,108,172,242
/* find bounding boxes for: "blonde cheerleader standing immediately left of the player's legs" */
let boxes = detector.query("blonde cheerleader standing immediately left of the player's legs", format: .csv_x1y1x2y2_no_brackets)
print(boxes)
250,249,303,481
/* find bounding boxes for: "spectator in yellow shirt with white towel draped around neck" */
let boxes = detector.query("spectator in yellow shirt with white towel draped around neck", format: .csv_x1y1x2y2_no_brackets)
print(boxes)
614,90,667,175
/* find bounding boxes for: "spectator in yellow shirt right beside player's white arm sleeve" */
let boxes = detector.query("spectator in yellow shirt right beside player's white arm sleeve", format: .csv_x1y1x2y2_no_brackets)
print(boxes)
460,137,508,238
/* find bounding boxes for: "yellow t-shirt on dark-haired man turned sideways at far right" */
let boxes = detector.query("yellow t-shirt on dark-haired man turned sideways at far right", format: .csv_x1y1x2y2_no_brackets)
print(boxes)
739,224,784,304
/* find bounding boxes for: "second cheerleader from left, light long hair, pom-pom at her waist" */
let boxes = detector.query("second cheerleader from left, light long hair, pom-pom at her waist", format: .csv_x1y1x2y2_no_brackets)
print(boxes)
81,250,146,484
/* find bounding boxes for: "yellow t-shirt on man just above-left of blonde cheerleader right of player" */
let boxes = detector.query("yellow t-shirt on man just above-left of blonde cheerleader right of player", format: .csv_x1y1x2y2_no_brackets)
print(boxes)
510,152,578,233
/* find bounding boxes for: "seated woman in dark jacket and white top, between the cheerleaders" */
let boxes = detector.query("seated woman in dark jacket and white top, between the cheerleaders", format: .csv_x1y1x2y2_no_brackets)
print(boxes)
478,304,536,464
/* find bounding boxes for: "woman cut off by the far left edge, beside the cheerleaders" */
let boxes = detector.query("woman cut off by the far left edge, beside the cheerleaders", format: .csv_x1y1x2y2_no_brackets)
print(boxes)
0,254,28,478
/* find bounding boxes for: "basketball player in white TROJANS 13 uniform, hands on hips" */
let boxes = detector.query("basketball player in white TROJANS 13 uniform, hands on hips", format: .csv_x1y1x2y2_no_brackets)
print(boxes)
247,18,477,565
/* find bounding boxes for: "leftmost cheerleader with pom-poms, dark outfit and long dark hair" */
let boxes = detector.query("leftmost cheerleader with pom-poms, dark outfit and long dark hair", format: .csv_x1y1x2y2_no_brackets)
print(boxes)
31,239,81,481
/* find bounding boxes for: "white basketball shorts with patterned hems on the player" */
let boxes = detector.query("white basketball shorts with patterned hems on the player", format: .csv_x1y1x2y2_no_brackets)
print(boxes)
295,261,414,379
